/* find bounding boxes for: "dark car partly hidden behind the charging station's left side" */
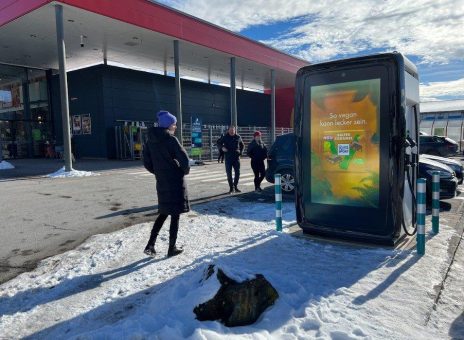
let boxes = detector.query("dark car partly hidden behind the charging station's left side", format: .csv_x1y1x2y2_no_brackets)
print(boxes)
266,133,295,194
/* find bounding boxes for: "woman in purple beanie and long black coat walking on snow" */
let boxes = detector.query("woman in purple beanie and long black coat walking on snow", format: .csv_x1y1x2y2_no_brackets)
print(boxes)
143,111,190,257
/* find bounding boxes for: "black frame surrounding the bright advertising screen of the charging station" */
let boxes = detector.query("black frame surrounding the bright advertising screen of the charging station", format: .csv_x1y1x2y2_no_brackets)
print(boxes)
294,53,406,244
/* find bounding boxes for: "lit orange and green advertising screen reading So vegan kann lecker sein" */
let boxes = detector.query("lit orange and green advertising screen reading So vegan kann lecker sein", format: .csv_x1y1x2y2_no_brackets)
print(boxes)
310,79,380,208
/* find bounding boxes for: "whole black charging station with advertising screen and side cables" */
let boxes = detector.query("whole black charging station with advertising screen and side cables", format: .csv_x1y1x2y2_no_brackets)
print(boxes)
294,52,419,245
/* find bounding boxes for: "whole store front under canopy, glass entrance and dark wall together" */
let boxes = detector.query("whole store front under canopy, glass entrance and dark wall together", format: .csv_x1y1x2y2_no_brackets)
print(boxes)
0,60,280,159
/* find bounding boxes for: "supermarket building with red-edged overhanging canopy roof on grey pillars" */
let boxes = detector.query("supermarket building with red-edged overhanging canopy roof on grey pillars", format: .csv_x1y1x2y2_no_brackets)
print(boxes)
0,0,308,158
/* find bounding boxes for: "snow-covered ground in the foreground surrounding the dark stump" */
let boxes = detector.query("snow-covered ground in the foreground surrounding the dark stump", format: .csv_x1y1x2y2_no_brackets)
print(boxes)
0,198,464,339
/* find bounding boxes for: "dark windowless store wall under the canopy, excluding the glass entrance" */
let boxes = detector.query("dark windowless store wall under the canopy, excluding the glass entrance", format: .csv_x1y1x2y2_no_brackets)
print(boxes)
51,64,271,158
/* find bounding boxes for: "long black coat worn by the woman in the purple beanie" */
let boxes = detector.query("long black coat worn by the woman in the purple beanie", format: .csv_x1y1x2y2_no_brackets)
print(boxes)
143,127,190,215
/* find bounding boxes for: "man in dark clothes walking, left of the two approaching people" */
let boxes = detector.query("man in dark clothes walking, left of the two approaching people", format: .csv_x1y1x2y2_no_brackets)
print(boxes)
218,125,245,194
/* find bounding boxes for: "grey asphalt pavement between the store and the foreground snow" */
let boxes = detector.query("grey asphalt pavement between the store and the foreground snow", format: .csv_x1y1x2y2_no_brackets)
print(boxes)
0,159,272,283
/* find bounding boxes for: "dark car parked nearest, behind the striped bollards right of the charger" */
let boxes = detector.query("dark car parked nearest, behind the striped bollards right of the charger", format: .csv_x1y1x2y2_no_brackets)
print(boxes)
417,156,458,201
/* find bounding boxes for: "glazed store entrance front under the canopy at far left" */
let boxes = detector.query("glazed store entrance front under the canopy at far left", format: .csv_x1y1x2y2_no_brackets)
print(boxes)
0,64,54,158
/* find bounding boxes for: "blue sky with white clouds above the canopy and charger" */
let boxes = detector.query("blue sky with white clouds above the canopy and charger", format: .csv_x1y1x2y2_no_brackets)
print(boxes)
160,0,464,101
